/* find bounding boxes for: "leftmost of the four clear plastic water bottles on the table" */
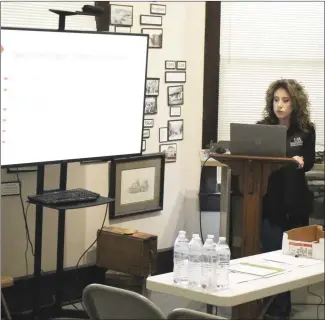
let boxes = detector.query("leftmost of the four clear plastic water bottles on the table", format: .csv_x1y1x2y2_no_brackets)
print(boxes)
173,231,188,285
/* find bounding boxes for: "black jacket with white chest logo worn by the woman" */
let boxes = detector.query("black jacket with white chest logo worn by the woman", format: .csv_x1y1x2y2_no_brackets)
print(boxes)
263,126,315,227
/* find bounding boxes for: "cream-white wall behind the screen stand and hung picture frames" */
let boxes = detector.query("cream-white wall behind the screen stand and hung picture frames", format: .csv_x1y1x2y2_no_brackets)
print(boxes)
1,2,205,276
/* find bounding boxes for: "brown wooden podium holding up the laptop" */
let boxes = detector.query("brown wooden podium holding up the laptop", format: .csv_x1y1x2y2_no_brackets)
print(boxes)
210,153,295,319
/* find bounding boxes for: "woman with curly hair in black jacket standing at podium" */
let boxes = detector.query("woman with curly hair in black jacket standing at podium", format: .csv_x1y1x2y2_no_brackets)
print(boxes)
259,79,315,319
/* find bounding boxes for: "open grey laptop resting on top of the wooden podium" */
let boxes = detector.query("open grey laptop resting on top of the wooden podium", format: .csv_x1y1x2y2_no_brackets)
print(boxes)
230,123,287,157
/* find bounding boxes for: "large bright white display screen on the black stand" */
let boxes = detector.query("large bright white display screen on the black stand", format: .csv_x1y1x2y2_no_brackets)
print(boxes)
1,28,148,167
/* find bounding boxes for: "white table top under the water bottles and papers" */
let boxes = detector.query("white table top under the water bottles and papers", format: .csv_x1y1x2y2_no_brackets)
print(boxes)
147,251,324,307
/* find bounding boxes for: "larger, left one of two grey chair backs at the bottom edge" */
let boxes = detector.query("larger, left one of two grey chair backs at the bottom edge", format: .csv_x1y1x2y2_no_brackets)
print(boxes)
83,284,166,320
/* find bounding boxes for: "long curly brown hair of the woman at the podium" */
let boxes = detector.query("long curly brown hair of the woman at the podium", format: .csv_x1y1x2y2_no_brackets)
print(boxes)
260,79,314,131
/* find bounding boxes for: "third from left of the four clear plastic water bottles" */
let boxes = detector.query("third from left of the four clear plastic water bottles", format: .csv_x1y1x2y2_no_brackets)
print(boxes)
201,236,217,291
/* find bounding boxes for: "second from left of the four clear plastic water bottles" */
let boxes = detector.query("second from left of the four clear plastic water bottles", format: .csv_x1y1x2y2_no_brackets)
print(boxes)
188,236,202,288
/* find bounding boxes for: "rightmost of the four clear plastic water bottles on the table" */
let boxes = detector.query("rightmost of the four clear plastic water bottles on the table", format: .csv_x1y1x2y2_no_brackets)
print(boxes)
216,237,230,290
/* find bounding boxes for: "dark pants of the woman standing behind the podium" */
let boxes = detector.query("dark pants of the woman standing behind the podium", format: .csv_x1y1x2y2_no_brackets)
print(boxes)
261,217,308,317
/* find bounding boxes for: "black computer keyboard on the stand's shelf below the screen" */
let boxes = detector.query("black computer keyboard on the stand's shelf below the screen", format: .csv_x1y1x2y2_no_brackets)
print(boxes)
28,188,99,205
